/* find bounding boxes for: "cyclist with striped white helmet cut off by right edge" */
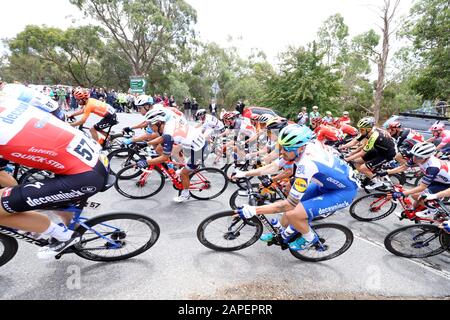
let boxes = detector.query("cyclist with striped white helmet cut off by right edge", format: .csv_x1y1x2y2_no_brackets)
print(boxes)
378,142,450,218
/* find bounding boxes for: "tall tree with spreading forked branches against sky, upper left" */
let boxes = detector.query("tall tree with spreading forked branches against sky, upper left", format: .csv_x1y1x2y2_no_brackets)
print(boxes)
70,0,197,76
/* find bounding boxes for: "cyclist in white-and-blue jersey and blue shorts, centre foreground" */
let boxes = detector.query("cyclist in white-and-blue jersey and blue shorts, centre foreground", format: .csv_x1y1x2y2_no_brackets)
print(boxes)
237,125,358,251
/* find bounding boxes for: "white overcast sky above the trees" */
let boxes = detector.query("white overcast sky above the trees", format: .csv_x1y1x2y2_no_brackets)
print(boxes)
0,0,413,62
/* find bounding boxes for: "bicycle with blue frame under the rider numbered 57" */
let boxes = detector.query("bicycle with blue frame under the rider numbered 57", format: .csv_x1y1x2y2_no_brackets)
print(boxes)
0,179,160,266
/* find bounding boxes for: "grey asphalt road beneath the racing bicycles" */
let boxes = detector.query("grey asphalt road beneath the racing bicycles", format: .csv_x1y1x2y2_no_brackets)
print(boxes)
0,115,450,300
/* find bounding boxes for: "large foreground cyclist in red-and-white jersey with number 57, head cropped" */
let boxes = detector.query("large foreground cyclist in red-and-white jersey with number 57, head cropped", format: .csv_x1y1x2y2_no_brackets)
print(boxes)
0,100,108,258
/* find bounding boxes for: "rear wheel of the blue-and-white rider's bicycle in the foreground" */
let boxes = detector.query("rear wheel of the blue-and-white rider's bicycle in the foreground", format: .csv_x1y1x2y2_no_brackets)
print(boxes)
290,223,353,262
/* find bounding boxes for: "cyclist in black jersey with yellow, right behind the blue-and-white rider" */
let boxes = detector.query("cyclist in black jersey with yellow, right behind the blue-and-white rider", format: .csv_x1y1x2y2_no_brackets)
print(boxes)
345,118,397,189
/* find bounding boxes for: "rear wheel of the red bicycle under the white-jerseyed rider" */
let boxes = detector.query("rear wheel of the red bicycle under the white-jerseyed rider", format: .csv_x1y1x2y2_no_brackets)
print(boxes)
189,168,228,200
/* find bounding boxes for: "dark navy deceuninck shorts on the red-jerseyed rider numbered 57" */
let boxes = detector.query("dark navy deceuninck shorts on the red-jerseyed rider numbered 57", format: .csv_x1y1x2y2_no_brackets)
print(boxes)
1,161,108,213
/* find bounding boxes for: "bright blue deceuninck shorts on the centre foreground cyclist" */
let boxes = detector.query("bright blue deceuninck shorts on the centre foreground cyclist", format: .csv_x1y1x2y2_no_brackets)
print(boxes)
300,182,358,222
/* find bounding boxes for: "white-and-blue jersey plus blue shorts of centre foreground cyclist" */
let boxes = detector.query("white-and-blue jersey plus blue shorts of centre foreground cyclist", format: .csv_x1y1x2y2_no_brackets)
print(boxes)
278,142,358,221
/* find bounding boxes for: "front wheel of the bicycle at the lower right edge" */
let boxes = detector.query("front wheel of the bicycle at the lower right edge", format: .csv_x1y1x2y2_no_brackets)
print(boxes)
384,224,446,258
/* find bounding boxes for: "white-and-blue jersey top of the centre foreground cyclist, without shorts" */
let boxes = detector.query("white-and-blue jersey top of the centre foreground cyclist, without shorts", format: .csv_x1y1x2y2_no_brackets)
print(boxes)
278,141,357,204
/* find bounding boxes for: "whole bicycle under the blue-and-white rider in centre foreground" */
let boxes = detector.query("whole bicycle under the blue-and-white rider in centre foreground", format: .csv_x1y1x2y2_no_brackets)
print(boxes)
197,179,353,262
